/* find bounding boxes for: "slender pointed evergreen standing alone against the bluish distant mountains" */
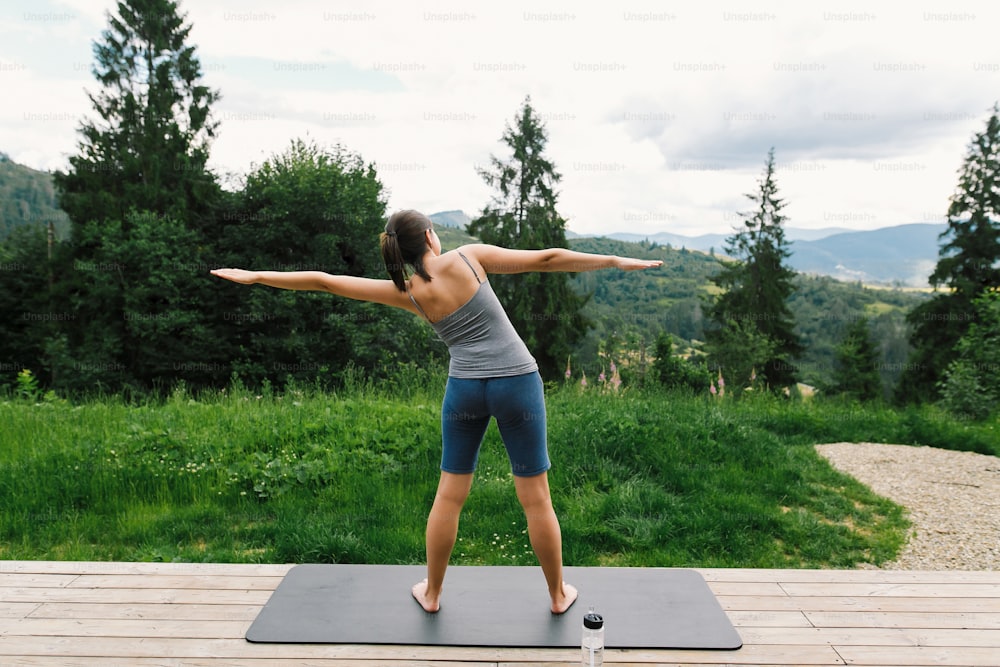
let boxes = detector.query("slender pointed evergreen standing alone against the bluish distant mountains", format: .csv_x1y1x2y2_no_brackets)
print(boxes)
705,148,802,389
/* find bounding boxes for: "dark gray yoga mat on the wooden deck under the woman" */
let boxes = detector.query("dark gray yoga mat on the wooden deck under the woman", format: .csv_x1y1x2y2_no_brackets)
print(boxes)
246,565,743,650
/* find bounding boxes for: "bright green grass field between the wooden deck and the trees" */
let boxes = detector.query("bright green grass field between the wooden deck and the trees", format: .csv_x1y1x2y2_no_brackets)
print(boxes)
0,373,1000,568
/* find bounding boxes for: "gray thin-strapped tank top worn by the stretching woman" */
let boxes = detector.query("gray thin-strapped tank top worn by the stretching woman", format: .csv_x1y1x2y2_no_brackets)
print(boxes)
407,253,538,379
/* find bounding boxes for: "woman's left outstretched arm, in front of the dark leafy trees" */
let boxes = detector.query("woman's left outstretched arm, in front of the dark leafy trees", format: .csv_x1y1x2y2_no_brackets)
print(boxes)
211,269,417,313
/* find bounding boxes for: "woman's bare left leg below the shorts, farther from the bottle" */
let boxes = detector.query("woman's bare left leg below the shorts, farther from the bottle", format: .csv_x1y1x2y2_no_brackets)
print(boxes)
413,472,472,612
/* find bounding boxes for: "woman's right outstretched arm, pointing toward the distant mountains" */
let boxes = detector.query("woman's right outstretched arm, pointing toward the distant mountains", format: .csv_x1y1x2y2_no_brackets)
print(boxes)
462,244,663,273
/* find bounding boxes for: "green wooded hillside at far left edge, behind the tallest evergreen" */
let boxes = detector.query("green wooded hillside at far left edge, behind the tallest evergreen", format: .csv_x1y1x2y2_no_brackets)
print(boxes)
0,153,70,240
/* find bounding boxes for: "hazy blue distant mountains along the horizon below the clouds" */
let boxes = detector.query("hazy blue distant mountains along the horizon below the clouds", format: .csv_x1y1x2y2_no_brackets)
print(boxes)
429,211,947,287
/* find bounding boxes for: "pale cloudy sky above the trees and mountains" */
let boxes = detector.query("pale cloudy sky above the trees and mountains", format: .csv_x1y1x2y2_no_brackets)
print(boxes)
0,0,1000,235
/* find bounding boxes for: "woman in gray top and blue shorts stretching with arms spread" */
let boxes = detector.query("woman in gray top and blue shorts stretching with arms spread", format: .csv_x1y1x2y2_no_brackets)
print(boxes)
212,211,661,614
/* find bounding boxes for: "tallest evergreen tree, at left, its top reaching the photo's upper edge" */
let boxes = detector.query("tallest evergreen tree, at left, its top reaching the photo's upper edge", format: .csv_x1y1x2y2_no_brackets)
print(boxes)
52,0,222,389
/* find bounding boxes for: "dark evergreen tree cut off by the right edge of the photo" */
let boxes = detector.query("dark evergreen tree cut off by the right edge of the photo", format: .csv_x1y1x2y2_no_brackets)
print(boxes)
900,105,1000,400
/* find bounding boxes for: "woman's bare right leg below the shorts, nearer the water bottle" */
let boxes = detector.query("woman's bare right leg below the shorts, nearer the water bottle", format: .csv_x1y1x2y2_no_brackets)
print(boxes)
514,472,577,614
